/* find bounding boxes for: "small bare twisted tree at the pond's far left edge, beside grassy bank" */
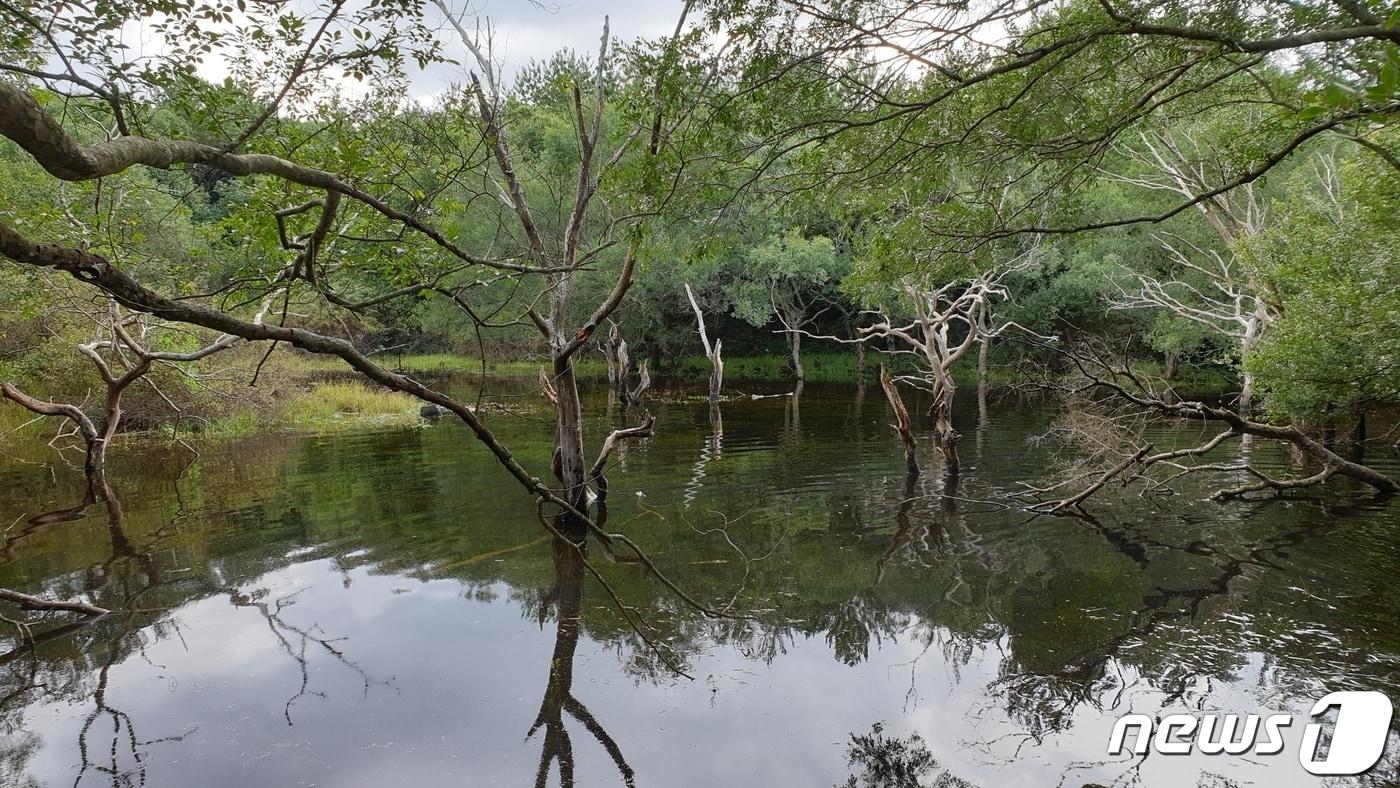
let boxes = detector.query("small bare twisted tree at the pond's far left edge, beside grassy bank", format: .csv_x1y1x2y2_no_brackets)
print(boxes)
0,300,252,476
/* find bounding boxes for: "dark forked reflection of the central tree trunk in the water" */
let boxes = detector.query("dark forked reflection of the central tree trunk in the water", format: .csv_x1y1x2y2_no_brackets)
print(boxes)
526,537,636,788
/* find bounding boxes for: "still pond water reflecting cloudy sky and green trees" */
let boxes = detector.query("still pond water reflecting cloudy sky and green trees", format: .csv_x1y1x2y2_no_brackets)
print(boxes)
0,381,1400,788
